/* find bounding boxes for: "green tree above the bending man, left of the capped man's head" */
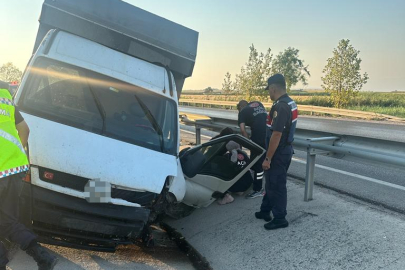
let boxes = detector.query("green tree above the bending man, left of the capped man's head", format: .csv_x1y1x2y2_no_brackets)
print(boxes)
223,44,272,100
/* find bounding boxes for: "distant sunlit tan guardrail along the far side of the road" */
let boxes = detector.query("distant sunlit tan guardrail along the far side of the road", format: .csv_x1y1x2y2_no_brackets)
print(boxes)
179,99,405,122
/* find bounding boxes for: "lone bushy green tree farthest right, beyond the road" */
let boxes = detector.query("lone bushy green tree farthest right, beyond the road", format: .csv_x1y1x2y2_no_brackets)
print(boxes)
321,39,369,108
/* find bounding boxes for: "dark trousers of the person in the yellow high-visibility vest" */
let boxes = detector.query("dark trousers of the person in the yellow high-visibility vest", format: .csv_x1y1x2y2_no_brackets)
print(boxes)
0,173,36,266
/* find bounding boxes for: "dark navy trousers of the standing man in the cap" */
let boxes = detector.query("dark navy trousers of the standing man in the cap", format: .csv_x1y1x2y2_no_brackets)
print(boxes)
260,145,294,219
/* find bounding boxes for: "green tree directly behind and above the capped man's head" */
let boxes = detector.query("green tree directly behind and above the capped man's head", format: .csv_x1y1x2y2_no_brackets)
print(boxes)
271,47,311,92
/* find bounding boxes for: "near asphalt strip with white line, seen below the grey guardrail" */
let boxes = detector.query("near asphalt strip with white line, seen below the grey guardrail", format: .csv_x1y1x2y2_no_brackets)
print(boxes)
182,126,405,213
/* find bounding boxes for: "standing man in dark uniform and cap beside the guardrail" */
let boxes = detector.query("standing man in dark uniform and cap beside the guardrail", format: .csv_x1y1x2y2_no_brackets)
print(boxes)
255,74,298,230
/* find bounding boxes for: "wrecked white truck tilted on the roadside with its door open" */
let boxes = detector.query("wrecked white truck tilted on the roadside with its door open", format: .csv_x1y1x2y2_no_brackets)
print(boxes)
15,0,263,250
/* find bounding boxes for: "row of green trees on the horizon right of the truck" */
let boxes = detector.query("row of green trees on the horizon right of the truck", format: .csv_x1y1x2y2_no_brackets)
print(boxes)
219,39,369,108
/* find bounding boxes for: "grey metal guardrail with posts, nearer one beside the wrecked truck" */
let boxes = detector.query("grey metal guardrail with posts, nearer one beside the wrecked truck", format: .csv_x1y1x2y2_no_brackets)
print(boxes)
181,115,405,201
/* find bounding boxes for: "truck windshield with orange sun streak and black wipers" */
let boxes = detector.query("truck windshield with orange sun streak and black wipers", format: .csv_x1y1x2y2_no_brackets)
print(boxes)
18,59,178,155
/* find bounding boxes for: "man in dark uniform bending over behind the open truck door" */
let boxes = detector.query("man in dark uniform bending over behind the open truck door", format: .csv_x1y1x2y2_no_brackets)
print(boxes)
237,100,267,198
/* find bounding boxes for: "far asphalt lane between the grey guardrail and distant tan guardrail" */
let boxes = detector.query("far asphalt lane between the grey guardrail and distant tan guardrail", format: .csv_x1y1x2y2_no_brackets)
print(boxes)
179,106,405,142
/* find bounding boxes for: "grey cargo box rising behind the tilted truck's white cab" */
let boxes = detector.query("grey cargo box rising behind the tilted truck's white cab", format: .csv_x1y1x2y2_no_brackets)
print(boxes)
34,0,198,95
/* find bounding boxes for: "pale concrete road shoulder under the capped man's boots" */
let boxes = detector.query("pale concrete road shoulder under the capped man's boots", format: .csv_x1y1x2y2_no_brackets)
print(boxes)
164,179,405,270
